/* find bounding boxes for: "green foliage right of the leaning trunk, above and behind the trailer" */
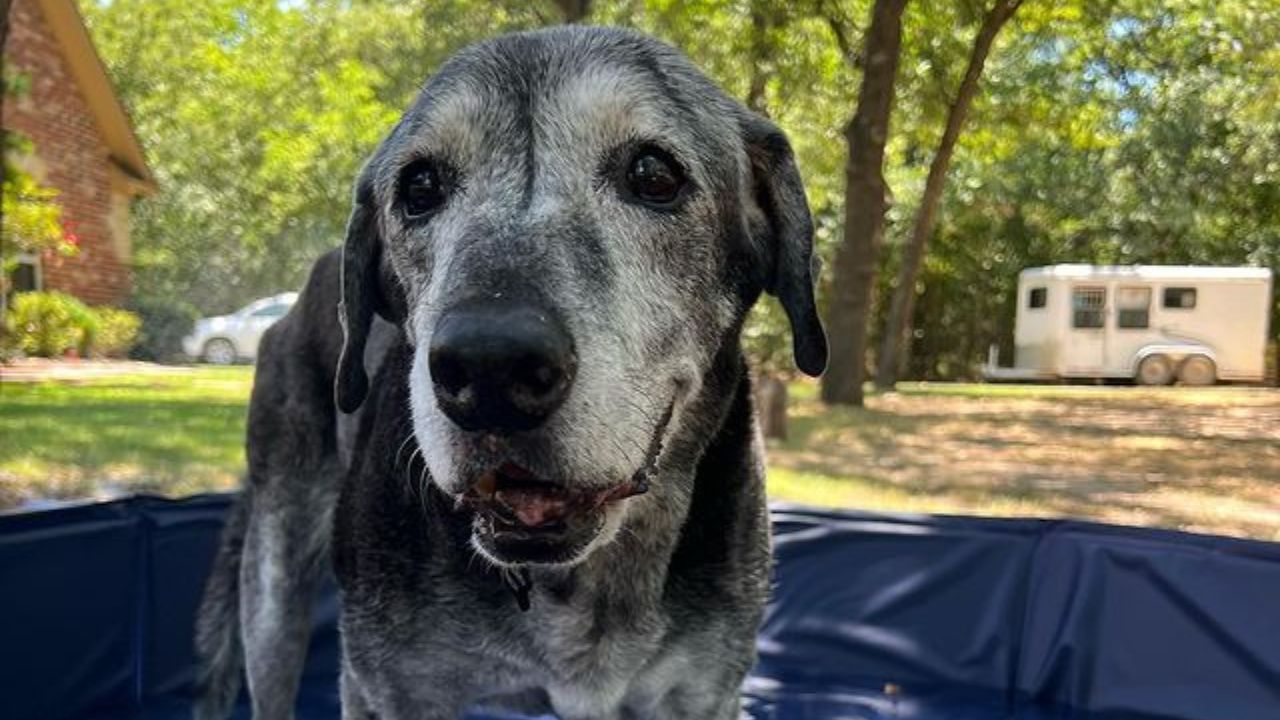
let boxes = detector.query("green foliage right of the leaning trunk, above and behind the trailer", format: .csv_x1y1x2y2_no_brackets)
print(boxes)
896,0,1280,378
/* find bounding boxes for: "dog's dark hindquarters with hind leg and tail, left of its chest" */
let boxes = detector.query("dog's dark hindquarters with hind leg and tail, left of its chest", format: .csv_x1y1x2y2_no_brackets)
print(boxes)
193,252,398,720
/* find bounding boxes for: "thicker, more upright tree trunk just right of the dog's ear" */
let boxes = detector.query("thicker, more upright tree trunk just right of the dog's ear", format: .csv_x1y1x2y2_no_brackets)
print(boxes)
822,0,906,405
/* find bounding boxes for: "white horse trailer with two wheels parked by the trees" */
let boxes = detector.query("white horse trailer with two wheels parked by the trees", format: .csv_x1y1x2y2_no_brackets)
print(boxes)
983,265,1271,386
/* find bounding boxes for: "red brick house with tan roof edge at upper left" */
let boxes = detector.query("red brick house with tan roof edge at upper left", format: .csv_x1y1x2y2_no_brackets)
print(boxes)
3,0,156,304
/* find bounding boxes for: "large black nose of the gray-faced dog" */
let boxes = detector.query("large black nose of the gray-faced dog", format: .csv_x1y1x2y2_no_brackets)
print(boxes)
429,302,577,433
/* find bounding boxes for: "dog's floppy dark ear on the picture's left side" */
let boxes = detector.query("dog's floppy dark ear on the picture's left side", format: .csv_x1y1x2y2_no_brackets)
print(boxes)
334,174,404,413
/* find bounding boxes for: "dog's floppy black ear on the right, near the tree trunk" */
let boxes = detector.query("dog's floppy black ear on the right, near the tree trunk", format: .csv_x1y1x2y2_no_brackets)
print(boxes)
742,113,827,377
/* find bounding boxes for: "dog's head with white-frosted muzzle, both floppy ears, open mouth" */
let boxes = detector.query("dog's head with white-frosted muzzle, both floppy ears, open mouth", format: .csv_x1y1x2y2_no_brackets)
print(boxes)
337,28,827,565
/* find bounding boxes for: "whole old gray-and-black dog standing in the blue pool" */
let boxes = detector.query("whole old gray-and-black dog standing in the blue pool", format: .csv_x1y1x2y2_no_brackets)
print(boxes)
197,28,827,720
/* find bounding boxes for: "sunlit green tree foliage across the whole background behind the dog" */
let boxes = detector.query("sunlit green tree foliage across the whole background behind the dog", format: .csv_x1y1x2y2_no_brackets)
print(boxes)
77,0,1280,378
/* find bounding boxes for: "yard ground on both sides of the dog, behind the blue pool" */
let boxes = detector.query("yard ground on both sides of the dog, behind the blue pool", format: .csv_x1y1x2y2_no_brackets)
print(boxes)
0,368,1280,541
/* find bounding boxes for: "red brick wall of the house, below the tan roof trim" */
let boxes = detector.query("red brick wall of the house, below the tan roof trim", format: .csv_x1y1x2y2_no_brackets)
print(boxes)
3,0,131,304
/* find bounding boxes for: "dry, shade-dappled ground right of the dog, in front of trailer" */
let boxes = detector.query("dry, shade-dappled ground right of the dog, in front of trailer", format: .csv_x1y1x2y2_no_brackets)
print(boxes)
769,383,1280,541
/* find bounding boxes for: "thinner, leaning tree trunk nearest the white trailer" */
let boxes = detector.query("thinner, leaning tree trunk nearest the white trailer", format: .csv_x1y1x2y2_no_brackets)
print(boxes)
876,0,1023,389
